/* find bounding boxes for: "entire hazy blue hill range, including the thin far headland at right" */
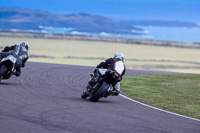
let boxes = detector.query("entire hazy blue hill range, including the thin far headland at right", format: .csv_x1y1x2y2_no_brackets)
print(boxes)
0,7,199,35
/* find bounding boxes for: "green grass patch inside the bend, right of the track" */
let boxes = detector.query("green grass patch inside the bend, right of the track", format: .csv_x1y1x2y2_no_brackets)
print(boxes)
121,74,200,119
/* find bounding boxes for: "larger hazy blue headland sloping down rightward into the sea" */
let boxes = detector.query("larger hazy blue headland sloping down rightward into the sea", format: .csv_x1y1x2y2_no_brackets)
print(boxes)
0,7,142,34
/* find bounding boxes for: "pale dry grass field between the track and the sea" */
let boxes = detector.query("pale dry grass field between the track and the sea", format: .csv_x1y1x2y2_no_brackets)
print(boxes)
0,33,200,73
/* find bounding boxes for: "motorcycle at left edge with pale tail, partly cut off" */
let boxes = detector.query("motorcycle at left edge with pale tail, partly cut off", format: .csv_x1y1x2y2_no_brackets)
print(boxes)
0,55,17,81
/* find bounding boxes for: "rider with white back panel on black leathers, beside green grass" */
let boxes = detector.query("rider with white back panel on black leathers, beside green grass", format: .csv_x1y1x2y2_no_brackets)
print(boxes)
86,52,126,96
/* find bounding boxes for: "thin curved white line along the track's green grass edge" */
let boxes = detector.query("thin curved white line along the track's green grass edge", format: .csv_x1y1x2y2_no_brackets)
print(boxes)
119,94,200,122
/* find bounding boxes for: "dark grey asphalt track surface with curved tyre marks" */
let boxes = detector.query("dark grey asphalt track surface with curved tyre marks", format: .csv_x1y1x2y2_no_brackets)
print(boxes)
0,63,200,133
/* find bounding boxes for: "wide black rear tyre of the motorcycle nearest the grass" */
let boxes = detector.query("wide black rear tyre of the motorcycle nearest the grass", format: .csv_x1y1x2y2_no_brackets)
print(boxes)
90,82,109,102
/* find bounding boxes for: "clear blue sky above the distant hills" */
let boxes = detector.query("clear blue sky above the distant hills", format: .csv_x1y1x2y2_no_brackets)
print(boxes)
0,0,200,24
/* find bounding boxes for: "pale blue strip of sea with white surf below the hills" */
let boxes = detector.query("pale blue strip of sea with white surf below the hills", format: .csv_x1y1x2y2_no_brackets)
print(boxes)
9,26,200,44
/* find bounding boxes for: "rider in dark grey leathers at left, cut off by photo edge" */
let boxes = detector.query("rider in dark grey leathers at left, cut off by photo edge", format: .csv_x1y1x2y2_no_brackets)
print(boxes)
0,42,29,77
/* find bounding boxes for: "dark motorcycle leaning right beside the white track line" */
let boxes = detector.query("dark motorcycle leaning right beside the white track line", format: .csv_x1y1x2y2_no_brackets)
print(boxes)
81,69,119,102
